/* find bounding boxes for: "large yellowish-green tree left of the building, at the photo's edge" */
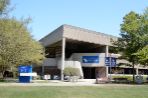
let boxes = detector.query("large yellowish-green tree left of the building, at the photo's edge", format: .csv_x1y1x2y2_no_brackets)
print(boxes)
0,0,44,78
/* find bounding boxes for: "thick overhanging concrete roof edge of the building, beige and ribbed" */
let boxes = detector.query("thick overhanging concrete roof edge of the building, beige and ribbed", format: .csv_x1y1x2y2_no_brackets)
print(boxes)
40,24,118,47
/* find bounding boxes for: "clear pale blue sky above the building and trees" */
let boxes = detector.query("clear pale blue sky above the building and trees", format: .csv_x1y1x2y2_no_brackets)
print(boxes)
11,0,148,40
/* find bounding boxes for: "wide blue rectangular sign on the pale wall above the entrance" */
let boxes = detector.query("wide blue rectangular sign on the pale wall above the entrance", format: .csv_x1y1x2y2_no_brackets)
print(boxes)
82,56,99,63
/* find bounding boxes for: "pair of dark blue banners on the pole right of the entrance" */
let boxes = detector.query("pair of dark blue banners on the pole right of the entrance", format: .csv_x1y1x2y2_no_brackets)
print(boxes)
105,57,116,67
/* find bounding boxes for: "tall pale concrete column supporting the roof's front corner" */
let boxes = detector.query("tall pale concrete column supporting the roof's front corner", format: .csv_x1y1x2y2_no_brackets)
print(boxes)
61,38,66,80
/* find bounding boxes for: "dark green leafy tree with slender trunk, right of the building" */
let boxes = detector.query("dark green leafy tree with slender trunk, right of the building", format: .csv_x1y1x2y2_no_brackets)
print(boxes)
115,8,148,80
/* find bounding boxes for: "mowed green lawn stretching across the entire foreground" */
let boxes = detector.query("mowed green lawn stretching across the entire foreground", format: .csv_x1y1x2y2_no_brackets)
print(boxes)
0,85,148,98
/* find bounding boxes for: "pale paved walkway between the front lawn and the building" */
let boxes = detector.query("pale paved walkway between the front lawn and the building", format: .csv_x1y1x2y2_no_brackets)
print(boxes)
0,79,143,87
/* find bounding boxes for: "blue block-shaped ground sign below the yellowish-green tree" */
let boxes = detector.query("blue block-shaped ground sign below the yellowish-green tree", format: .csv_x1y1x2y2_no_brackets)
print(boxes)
18,65,32,83
